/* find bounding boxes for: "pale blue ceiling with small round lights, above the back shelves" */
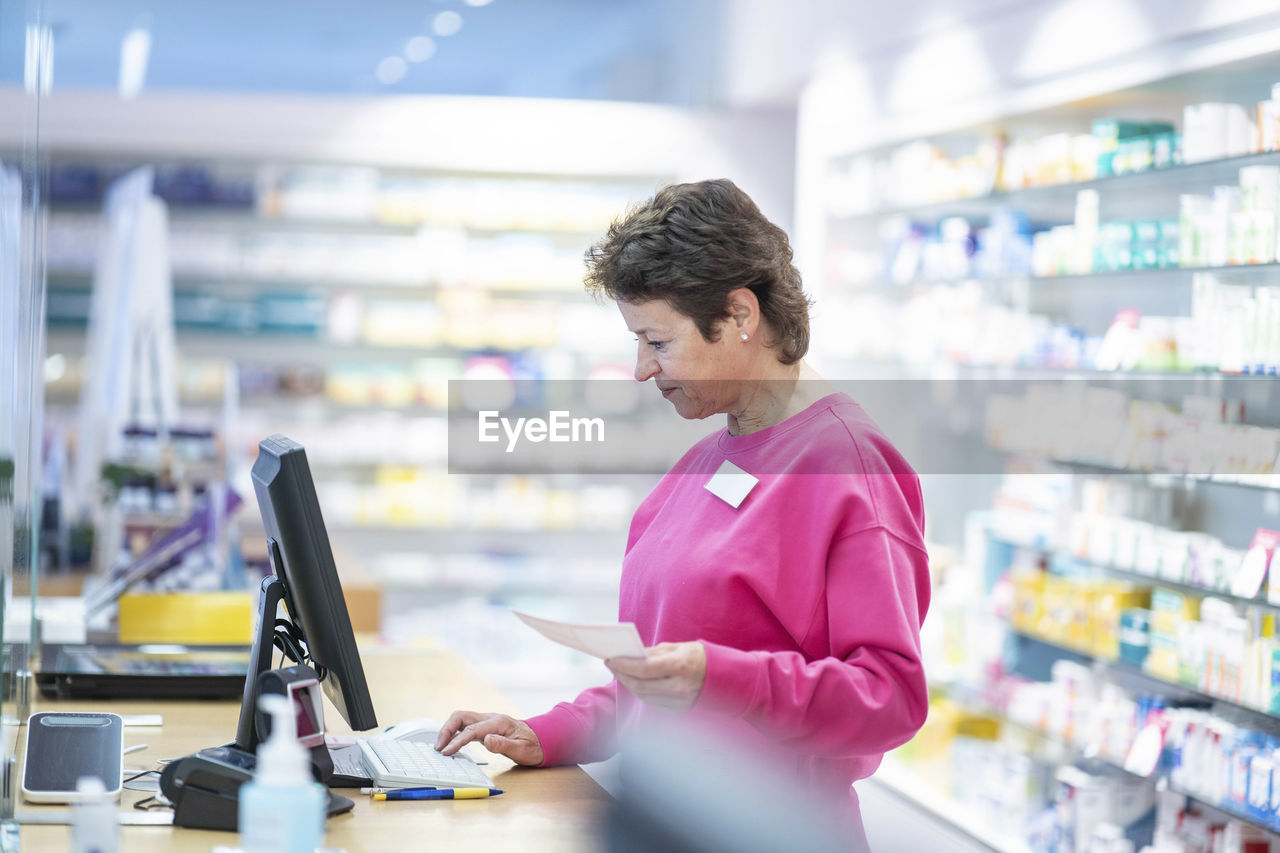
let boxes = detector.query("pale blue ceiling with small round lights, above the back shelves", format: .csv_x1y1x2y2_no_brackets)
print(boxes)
0,0,721,105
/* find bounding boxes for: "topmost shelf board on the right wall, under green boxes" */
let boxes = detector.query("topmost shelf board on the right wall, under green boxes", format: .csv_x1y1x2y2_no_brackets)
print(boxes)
831,151,1280,223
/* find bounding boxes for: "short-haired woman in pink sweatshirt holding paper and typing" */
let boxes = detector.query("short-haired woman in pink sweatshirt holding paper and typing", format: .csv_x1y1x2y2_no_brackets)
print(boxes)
436,175,929,831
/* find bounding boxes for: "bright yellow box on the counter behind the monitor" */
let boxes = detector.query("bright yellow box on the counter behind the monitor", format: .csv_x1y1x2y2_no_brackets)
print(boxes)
119,590,256,646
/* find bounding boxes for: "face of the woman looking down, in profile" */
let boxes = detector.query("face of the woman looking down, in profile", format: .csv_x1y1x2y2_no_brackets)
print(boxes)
617,300,750,419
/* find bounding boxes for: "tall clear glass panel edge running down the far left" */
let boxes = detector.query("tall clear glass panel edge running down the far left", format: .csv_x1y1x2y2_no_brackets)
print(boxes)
0,0,52,835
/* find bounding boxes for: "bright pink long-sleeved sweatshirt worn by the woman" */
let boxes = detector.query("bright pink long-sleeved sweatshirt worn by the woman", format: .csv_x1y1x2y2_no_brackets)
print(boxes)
527,394,929,802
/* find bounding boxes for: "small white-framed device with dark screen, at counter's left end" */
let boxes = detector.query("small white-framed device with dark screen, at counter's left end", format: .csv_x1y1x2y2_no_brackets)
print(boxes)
22,711,124,803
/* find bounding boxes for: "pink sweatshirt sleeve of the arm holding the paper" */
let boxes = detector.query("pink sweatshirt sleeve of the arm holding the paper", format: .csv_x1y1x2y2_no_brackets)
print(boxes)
695,526,929,758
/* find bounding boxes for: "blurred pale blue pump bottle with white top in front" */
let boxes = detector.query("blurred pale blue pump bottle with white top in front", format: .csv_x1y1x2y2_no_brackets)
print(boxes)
239,694,328,853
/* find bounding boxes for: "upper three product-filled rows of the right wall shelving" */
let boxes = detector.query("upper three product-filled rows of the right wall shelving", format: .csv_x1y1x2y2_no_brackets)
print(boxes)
814,74,1280,374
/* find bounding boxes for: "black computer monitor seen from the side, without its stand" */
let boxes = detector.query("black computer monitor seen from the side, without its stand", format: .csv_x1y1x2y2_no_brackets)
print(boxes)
252,435,378,731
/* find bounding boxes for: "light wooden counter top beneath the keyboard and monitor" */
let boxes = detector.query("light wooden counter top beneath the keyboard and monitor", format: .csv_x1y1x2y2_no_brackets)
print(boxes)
18,648,608,853
